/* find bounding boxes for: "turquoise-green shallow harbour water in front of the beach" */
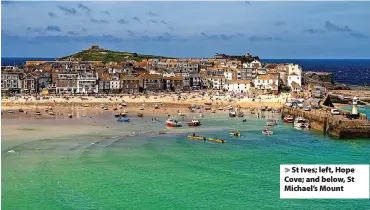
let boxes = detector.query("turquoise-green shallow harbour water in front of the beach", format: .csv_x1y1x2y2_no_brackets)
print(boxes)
2,110,370,209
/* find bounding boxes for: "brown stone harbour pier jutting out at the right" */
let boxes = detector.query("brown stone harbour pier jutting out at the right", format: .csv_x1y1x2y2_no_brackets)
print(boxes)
282,107,370,139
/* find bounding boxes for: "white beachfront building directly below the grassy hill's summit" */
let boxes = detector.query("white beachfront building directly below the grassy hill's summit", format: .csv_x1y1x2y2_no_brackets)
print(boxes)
77,72,99,93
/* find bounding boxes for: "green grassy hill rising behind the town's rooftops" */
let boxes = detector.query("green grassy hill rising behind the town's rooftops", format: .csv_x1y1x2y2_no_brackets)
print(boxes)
57,46,170,63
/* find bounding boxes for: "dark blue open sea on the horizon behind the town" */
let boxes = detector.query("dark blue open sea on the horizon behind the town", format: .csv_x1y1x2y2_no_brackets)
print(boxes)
1,57,370,85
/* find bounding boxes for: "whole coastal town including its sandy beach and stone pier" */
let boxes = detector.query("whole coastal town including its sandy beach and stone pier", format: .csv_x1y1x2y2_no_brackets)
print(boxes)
1,45,370,139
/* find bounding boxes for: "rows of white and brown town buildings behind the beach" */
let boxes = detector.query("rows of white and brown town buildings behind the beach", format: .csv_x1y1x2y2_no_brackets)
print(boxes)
1,46,316,95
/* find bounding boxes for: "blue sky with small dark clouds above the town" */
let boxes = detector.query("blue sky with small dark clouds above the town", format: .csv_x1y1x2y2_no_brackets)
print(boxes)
1,1,370,58
